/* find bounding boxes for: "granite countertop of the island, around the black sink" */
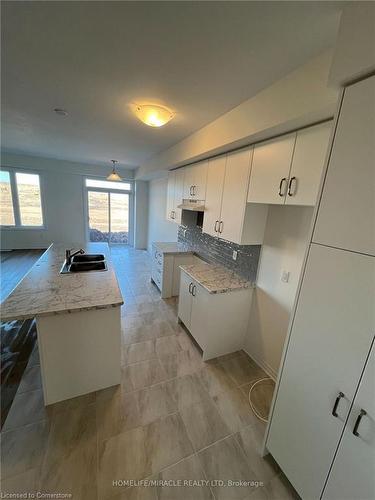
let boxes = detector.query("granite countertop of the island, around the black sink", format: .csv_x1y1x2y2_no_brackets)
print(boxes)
1,243,124,321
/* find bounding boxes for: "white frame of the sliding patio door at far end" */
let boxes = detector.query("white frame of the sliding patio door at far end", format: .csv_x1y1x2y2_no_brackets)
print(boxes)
82,175,135,246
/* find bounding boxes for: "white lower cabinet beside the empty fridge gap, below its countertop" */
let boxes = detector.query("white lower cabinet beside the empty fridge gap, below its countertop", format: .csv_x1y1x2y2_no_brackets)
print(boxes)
178,270,252,361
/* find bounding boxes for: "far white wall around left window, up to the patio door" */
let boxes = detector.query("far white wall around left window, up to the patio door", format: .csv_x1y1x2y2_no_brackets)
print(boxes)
1,153,133,249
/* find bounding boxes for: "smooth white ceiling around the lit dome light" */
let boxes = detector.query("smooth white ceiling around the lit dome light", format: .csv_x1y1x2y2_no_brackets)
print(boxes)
2,1,342,167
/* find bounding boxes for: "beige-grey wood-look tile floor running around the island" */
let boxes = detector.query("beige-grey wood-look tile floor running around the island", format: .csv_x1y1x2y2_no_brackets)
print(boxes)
1,247,298,500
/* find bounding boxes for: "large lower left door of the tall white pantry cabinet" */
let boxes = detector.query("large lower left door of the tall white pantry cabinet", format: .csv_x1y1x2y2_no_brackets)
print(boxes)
266,244,375,499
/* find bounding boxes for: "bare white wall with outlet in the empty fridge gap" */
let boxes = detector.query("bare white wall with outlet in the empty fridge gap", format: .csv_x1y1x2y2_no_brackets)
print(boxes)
245,205,313,376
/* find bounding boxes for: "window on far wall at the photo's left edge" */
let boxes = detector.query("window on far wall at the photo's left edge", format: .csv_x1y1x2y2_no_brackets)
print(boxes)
0,170,43,227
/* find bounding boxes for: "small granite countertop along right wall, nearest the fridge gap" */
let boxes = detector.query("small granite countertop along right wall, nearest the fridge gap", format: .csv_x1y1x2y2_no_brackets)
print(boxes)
180,262,253,293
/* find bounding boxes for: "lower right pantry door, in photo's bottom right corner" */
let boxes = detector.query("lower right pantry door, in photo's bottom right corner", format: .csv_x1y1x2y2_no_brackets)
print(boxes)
323,340,375,500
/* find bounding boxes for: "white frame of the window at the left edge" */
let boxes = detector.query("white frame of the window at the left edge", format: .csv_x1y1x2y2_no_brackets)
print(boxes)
0,165,47,231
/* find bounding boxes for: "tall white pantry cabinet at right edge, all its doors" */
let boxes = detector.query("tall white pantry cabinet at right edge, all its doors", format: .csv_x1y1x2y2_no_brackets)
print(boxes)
266,76,375,500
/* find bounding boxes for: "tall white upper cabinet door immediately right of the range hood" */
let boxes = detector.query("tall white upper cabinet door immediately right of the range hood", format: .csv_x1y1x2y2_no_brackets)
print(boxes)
203,156,226,236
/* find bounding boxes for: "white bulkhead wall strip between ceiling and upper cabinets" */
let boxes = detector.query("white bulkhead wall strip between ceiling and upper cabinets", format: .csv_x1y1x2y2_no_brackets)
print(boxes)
136,50,338,179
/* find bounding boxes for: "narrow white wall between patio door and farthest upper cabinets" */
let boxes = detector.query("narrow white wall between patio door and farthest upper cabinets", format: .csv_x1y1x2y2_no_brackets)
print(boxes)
148,177,178,252
